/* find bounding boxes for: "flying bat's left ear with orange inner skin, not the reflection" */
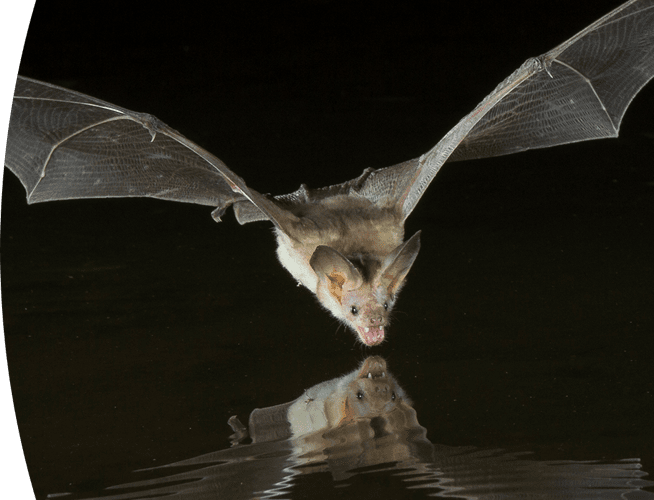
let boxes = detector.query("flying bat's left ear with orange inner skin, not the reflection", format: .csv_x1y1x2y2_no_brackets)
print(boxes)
309,245,363,303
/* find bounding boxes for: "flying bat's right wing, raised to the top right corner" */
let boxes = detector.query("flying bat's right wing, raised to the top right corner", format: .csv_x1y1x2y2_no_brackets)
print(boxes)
368,0,654,219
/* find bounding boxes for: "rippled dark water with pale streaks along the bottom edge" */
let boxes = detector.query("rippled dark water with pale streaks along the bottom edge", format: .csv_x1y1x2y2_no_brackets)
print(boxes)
33,428,654,500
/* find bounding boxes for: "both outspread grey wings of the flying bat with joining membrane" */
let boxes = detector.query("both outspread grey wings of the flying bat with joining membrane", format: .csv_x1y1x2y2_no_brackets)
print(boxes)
5,0,654,229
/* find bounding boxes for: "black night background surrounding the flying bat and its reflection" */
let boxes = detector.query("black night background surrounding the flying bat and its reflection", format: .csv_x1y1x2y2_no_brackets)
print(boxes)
0,0,654,499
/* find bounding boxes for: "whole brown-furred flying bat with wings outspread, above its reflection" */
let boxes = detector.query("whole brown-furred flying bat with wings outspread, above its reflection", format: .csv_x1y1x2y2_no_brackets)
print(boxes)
5,0,654,346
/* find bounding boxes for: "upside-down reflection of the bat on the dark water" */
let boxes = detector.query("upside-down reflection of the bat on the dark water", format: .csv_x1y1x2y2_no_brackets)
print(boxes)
228,356,412,443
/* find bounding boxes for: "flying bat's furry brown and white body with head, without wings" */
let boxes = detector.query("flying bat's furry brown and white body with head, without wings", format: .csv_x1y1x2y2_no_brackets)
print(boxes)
276,178,420,345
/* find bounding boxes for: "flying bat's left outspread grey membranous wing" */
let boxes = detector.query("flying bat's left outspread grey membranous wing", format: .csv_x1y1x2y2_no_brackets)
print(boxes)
5,76,295,229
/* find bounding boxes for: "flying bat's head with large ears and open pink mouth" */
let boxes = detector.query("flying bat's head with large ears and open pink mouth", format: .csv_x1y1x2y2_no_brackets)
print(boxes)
310,232,420,346
